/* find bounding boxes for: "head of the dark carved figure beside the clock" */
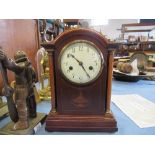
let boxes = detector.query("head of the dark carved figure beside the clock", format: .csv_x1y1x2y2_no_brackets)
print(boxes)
14,51,27,63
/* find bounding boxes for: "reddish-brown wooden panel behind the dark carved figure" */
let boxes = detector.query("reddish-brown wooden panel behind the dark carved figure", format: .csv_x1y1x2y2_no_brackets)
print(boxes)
0,19,39,90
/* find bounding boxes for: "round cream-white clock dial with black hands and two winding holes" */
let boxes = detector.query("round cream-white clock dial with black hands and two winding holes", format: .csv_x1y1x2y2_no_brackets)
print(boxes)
59,40,104,84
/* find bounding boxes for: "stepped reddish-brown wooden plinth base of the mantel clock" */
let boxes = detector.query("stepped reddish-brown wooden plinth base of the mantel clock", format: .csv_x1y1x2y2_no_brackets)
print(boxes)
45,112,118,132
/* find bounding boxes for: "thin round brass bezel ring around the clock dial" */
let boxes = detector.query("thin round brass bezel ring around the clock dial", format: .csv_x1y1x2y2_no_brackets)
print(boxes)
58,39,104,86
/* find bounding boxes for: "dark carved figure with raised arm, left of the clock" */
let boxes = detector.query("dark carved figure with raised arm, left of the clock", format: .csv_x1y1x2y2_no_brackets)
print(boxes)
0,50,36,130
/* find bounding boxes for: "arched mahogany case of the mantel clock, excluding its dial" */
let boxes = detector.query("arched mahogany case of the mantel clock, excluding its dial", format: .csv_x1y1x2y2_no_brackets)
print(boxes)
44,29,117,132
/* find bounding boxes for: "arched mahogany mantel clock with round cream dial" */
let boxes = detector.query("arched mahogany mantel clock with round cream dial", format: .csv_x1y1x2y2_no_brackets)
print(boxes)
43,29,117,132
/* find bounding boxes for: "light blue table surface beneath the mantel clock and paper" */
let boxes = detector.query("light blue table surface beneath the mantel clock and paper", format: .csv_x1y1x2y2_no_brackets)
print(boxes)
0,79,155,135
